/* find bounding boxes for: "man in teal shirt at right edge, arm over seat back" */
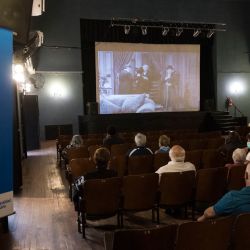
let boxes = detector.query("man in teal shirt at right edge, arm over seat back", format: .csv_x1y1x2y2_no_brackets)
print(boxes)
197,153,250,221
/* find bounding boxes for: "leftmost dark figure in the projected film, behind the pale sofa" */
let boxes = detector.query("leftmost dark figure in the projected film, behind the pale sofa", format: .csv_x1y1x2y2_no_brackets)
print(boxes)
119,64,134,95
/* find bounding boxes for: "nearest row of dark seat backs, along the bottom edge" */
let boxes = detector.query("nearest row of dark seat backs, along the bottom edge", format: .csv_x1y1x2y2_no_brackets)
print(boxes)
104,214,250,250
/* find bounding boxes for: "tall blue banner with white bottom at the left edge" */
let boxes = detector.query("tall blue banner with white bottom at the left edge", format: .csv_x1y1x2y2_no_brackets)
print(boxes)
0,28,14,218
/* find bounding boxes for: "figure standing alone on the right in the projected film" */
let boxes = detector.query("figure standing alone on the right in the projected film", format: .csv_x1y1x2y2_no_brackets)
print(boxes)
163,65,180,111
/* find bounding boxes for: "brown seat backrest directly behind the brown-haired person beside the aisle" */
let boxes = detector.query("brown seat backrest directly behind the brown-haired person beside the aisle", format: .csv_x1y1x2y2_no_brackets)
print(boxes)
83,177,122,215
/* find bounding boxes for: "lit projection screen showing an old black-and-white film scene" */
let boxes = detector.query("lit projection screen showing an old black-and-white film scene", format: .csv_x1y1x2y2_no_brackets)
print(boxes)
95,42,200,114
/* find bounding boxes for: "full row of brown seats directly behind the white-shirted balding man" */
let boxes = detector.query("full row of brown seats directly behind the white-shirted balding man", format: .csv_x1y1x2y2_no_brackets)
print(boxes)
70,167,245,237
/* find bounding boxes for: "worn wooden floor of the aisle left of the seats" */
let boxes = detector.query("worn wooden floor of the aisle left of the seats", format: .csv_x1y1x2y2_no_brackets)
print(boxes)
0,141,104,250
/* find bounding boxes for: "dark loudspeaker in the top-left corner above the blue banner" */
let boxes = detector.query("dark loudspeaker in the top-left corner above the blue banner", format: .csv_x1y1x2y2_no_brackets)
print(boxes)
0,0,33,44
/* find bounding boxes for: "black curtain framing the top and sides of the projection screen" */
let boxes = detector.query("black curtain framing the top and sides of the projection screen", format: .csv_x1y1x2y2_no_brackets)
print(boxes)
81,19,216,113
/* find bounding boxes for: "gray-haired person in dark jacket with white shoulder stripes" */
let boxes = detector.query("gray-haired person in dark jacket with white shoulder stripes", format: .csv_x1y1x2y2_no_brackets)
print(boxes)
128,133,153,157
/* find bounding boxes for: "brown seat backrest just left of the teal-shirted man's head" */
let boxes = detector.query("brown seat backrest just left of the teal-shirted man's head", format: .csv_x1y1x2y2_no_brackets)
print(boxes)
227,165,246,190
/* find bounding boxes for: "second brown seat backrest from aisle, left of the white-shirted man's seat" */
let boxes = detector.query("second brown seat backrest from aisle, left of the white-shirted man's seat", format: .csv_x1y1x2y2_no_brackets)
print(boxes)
123,173,159,211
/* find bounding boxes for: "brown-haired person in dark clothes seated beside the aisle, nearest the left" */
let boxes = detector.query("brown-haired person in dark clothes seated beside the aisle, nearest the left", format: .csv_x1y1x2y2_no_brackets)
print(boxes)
73,147,117,211
